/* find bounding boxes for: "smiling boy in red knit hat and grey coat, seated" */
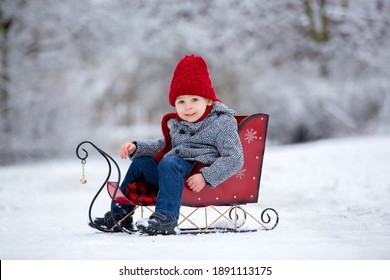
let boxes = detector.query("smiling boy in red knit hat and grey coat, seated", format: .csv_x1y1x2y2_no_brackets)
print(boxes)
94,55,243,235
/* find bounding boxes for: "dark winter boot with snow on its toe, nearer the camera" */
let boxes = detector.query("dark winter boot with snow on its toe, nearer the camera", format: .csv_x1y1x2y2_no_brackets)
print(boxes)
135,212,180,235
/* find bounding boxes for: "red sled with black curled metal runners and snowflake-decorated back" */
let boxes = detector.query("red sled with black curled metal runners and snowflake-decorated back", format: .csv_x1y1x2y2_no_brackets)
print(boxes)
76,114,279,234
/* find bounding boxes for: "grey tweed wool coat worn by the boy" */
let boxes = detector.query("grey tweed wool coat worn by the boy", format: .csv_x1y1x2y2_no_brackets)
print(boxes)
130,102,244,188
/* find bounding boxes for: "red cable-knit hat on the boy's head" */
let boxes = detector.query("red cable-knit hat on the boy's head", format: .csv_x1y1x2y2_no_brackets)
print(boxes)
168,55,220,106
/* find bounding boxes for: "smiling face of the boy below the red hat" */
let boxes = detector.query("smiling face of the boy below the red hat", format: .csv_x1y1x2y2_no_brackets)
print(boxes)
175,95,212,122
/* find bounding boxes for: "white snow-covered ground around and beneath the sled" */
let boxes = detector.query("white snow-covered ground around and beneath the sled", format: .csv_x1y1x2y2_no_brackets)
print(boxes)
0,136,390,260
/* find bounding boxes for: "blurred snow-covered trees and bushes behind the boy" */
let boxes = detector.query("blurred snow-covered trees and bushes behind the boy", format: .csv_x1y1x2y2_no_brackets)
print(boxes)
0,0,390,165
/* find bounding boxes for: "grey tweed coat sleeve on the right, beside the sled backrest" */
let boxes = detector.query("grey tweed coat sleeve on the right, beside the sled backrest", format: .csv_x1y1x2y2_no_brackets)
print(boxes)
200,118,244,188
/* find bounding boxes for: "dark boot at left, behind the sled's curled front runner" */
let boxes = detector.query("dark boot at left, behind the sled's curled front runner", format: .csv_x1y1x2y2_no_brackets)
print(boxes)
89,211,134,232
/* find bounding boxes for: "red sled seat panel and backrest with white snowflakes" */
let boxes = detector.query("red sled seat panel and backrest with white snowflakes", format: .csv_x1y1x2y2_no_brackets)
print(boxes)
182,114,268,207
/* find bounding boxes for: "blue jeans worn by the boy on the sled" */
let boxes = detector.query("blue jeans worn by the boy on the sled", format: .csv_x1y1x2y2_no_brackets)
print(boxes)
114,156,192,219
